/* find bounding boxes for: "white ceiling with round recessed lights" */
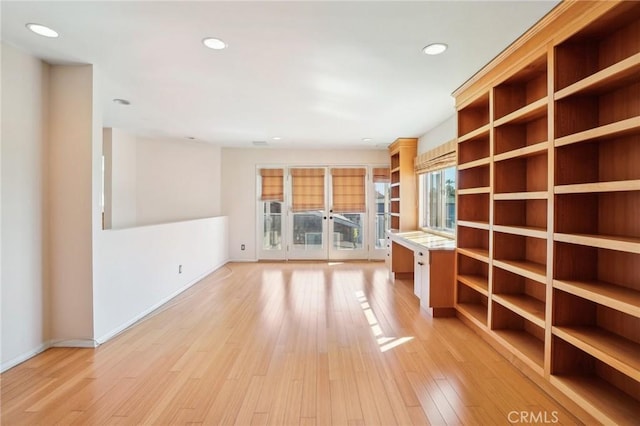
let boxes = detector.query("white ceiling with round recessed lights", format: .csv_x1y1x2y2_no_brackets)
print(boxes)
0,0,558,148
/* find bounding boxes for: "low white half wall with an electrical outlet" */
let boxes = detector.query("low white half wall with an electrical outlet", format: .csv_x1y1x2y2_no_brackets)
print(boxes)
94,217,228,342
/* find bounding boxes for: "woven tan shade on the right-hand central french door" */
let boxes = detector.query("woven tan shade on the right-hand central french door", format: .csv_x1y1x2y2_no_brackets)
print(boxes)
331,168,367,213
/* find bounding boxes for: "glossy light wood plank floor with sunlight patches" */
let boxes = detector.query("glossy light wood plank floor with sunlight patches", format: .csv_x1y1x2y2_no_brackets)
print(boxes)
1,263,578,425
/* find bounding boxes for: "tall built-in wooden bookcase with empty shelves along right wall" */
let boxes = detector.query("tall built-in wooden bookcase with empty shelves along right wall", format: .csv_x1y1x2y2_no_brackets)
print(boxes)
454,1,640,424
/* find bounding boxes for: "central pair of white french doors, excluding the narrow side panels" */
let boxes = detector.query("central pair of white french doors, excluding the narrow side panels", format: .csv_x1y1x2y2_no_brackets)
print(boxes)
287,167,369,260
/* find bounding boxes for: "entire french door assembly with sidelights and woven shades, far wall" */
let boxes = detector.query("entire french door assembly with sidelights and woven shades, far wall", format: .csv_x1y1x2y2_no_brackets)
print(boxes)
257,166,389,260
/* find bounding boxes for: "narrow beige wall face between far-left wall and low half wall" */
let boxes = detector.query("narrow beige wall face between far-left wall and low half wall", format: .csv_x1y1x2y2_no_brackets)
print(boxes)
49,65,95,342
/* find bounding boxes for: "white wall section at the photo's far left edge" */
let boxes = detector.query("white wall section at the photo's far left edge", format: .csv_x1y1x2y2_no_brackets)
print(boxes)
0,44,49,370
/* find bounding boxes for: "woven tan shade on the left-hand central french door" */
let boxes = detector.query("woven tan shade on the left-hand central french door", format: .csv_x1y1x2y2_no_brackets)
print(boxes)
291,169,324,212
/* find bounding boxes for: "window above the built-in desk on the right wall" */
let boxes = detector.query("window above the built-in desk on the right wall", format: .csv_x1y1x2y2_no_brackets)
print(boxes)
420,167,456,233
